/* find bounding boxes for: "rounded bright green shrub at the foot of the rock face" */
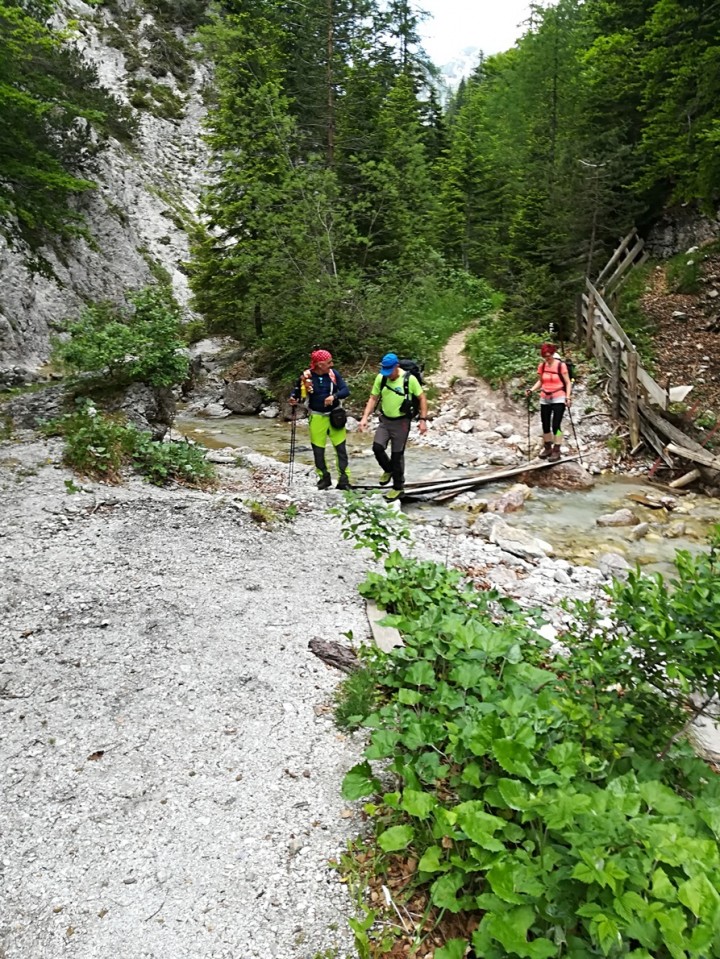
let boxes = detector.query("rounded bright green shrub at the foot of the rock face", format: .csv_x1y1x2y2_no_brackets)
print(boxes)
53,286,187,387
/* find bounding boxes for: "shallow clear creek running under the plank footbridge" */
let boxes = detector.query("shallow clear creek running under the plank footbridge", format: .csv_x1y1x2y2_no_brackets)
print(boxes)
175,414,720,572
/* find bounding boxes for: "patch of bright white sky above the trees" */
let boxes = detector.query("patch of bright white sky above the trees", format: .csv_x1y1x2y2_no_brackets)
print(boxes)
415,0,529,66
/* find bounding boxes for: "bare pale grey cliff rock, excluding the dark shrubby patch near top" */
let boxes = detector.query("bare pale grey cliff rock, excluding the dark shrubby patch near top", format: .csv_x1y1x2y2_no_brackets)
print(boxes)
0,0,207,374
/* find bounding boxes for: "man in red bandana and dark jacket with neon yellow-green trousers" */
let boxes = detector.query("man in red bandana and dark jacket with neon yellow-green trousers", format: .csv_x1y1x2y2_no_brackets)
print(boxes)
290,350,350,489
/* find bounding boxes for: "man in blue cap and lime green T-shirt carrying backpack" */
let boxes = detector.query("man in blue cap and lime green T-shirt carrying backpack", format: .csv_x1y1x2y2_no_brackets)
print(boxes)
358,353,427,500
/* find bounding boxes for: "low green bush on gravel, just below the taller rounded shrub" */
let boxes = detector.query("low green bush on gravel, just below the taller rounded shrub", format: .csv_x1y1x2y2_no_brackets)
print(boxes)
44,401,215,487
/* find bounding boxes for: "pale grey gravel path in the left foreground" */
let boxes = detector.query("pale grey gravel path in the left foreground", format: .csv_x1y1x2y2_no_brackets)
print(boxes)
0,442,369,959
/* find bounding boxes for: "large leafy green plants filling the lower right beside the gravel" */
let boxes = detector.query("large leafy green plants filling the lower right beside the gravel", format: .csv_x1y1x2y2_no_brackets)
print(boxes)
343,524,720,959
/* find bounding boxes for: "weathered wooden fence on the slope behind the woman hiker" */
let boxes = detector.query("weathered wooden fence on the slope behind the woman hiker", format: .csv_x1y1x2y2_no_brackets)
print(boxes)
577,231,720,485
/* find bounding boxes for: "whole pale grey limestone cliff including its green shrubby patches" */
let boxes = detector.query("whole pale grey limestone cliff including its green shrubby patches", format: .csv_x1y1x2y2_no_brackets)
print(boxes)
0,0,209,382
